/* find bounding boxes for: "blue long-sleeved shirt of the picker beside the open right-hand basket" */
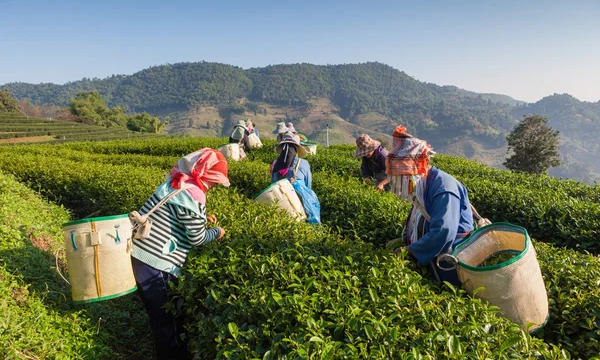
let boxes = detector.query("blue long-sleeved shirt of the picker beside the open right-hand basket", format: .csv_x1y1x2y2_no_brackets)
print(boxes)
409,167,473,266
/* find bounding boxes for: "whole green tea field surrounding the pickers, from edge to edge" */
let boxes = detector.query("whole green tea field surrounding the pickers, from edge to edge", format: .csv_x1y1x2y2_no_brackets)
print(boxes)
0,138,600,359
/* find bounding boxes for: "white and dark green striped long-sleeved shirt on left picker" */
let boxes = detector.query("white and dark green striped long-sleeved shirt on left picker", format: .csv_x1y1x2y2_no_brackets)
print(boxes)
131,194,219,276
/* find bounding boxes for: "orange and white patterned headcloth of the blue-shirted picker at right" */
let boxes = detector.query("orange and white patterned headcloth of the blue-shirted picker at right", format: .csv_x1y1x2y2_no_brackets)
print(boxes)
385,126,435,176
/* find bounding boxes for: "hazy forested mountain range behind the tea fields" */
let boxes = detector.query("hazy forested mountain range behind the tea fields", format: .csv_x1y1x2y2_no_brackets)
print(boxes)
2,62,600,182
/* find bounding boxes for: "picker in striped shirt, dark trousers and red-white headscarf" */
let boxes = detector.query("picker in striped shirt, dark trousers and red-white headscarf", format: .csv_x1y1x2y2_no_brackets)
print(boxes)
131,148,229,359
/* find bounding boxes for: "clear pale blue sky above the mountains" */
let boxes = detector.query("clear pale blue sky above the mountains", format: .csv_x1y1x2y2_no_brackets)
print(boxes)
0,0,600,101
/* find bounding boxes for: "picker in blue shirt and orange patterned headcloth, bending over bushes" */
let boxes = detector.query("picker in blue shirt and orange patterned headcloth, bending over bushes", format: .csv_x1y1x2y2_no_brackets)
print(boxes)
386,126,474,286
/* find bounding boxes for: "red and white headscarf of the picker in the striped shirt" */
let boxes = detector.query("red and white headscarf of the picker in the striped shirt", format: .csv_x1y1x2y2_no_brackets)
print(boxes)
167,148,230,204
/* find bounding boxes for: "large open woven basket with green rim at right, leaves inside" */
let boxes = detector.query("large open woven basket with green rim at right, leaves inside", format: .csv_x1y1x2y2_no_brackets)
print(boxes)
437,223,548,332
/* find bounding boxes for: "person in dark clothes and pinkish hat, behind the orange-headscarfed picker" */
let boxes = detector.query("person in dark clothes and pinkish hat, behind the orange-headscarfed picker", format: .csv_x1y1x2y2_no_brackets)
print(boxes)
354,134,390,191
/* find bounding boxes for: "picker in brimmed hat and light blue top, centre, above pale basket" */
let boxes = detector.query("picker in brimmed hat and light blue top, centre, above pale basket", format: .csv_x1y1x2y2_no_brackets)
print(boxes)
271,131,312,189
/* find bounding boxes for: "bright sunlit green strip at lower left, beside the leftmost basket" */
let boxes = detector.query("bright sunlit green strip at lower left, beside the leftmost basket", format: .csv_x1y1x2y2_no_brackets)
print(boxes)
0,174,152,360
